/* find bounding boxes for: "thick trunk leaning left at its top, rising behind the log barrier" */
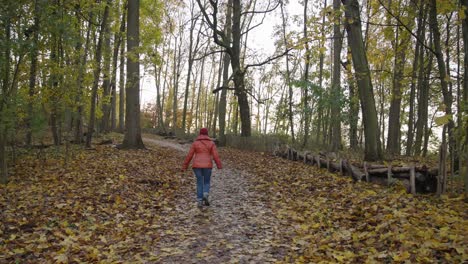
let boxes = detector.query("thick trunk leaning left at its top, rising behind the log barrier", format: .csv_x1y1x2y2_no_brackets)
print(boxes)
341,0,382,161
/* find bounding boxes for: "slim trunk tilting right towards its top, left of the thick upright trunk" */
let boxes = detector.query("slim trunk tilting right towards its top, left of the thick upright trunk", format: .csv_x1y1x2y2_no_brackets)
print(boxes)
86,0,112,148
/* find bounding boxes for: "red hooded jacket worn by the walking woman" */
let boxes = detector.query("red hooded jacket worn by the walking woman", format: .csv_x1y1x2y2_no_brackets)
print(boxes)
182,135,223,170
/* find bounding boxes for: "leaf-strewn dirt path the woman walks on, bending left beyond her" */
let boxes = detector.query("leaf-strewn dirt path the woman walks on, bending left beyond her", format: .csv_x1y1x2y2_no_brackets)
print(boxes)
144,138,281,263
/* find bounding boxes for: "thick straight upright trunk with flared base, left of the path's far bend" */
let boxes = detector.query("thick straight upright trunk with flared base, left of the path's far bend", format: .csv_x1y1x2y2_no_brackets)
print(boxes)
120,0,145,149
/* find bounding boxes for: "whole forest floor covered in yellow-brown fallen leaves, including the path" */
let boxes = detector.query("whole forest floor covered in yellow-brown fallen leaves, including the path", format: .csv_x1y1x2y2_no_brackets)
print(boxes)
0,136,468,263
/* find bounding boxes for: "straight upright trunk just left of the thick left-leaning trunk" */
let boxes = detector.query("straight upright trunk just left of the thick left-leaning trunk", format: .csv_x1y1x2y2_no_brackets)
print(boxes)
330,0,343,152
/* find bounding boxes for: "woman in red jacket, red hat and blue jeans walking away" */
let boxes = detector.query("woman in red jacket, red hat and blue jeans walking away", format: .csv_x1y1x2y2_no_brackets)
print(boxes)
182,128,223,207
